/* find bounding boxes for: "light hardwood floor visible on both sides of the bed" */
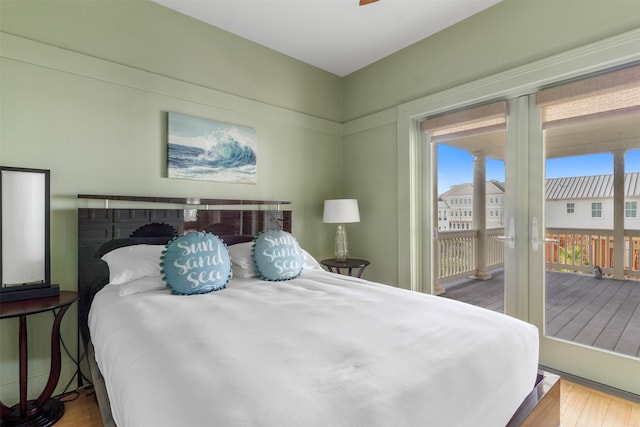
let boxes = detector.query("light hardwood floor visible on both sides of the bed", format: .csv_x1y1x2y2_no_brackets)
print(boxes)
56,380,640,427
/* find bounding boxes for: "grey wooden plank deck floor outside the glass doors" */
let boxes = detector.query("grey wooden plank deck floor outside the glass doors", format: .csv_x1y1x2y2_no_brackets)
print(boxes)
442,270,640,357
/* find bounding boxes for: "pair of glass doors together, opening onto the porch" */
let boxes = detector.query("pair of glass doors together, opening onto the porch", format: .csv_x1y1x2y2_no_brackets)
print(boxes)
422,63,640,394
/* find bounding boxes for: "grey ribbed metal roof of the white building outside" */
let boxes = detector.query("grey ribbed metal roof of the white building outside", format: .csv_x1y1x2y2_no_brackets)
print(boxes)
546,172,640,200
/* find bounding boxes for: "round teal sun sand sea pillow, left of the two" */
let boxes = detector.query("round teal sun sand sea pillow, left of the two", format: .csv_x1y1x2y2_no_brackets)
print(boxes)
160,231,231,295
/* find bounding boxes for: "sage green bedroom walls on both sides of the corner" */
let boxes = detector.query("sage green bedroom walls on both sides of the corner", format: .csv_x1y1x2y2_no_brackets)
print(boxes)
0,0,638,424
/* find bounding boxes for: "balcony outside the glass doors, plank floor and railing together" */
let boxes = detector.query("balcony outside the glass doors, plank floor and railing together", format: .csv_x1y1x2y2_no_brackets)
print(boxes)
438,229,640,357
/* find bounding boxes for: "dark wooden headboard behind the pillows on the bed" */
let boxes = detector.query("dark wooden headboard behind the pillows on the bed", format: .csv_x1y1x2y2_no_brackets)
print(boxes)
78,195,292,345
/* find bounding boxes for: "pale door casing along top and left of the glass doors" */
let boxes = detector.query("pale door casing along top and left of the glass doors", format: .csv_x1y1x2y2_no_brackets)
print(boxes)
396,25,640,293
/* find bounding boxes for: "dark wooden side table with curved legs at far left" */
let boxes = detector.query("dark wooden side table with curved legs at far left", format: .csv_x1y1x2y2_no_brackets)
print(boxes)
0,291,79,427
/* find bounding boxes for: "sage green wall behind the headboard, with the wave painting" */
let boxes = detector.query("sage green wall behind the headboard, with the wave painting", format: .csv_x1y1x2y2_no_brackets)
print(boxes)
0,0,343,404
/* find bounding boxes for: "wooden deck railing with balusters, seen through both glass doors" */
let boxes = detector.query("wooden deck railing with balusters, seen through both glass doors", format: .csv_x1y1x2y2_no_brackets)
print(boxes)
437,228,640,284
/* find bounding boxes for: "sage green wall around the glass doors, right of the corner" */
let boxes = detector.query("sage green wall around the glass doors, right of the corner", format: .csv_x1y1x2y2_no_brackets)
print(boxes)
342,0,640,287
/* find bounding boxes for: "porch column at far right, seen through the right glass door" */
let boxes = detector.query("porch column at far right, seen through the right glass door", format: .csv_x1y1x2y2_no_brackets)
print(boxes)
613,150,625,280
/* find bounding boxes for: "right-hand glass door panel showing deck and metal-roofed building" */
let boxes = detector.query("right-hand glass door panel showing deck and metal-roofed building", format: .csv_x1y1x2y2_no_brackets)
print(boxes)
529,66,640,394
